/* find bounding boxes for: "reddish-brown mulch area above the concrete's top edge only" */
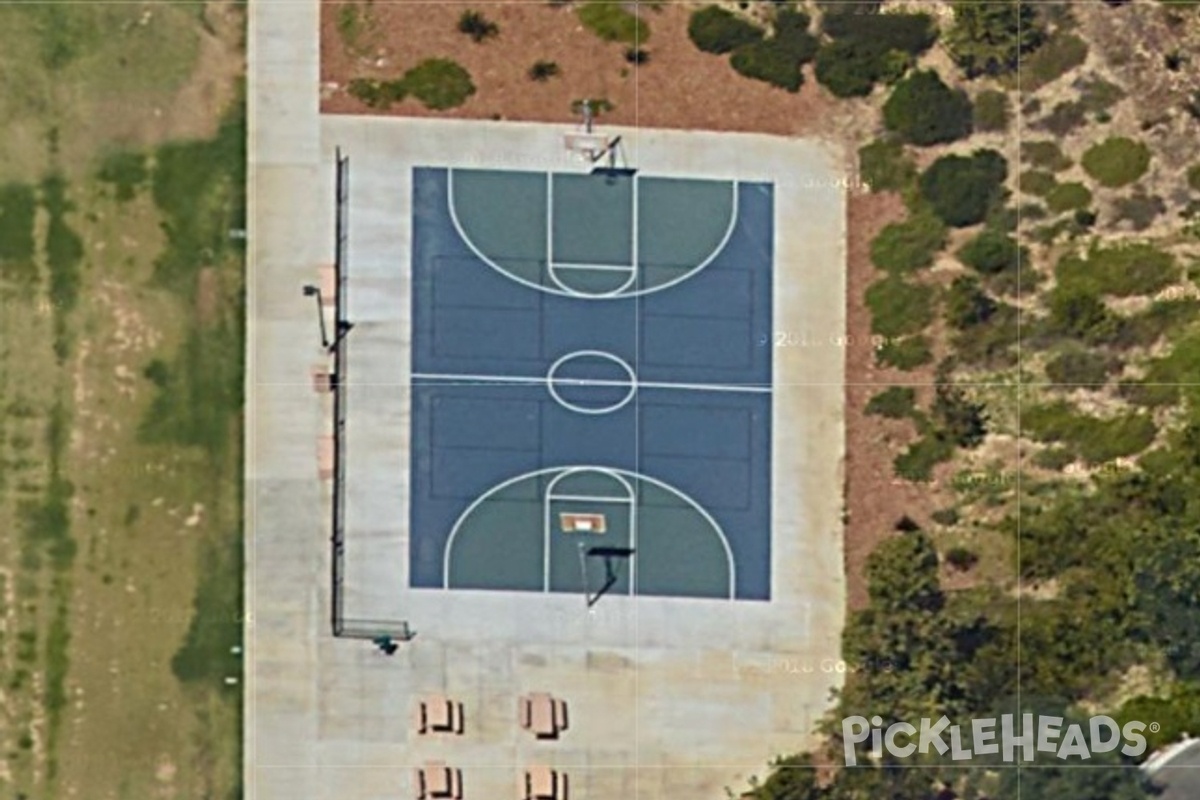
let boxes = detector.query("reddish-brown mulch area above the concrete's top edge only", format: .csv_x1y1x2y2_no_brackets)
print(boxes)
320,0,836,136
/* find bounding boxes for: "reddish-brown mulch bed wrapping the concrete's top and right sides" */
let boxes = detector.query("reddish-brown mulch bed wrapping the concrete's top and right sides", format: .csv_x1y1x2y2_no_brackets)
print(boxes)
320,0,938,608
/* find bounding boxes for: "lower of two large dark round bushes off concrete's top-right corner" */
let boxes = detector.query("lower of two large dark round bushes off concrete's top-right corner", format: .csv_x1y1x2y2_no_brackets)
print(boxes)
920,150,1008,228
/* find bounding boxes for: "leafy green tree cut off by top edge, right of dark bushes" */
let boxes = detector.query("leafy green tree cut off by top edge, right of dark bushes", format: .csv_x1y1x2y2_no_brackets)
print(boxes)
946,0,1045,78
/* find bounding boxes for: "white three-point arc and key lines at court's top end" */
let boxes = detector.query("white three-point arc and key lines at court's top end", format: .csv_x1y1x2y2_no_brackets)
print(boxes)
445,167,742,300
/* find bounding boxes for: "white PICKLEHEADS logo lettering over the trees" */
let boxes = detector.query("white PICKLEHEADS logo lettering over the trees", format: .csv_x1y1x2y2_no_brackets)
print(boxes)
841,714,1158,766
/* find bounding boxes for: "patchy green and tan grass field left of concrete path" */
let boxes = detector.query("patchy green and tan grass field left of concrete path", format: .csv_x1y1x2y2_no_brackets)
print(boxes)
0,2,245,800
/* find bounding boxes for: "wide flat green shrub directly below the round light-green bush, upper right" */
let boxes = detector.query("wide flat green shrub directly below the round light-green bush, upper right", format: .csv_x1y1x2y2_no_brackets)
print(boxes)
1055,242,1180,297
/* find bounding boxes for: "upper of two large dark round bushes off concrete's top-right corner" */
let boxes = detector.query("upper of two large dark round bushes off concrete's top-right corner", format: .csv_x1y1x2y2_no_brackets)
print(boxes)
883,70,972,146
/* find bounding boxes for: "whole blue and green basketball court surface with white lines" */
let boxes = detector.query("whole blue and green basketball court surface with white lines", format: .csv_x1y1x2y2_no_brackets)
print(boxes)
410,168,773,600
